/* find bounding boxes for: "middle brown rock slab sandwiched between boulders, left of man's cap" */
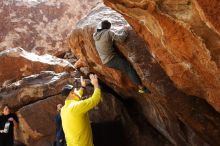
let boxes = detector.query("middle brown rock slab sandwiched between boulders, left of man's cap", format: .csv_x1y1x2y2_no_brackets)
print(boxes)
0,71,74,109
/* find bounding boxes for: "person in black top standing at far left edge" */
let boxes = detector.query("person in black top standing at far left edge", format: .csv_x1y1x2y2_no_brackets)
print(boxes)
0,104,18,146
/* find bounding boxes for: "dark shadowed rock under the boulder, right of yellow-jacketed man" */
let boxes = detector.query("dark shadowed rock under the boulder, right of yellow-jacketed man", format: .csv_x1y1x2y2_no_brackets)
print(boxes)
87,85,172,146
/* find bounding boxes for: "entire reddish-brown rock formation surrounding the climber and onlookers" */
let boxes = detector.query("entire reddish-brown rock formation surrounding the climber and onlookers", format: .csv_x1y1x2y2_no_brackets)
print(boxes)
0,0,220,146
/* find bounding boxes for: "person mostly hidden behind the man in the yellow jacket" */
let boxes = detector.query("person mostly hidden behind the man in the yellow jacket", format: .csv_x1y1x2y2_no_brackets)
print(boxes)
55,104,66,146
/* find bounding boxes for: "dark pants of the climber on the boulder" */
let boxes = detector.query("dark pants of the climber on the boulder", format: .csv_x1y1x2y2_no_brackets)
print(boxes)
106,56,141,85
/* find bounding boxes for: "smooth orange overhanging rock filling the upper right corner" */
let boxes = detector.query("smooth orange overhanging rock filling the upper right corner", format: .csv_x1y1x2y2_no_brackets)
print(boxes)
105,0,220,112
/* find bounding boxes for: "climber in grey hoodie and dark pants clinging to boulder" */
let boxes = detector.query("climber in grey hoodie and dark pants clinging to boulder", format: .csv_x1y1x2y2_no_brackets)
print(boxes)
93,20,150,93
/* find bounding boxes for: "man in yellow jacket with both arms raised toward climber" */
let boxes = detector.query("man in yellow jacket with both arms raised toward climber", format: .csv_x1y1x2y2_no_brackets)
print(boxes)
61,74,101,146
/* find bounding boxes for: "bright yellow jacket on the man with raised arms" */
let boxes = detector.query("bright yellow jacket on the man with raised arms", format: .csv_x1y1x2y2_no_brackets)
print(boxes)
61,88,101,146
